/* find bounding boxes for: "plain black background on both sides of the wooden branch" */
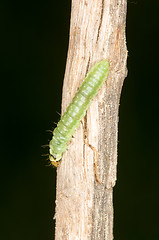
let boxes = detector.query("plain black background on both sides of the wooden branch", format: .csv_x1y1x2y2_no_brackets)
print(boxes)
0,0,159,240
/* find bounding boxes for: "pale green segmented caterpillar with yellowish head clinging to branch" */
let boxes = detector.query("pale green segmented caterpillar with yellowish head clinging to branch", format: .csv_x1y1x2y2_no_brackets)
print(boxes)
49,60,109,167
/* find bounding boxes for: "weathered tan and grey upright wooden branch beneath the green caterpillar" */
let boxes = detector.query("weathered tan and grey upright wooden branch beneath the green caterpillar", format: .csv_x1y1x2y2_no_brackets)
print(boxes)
55,0,127,240
